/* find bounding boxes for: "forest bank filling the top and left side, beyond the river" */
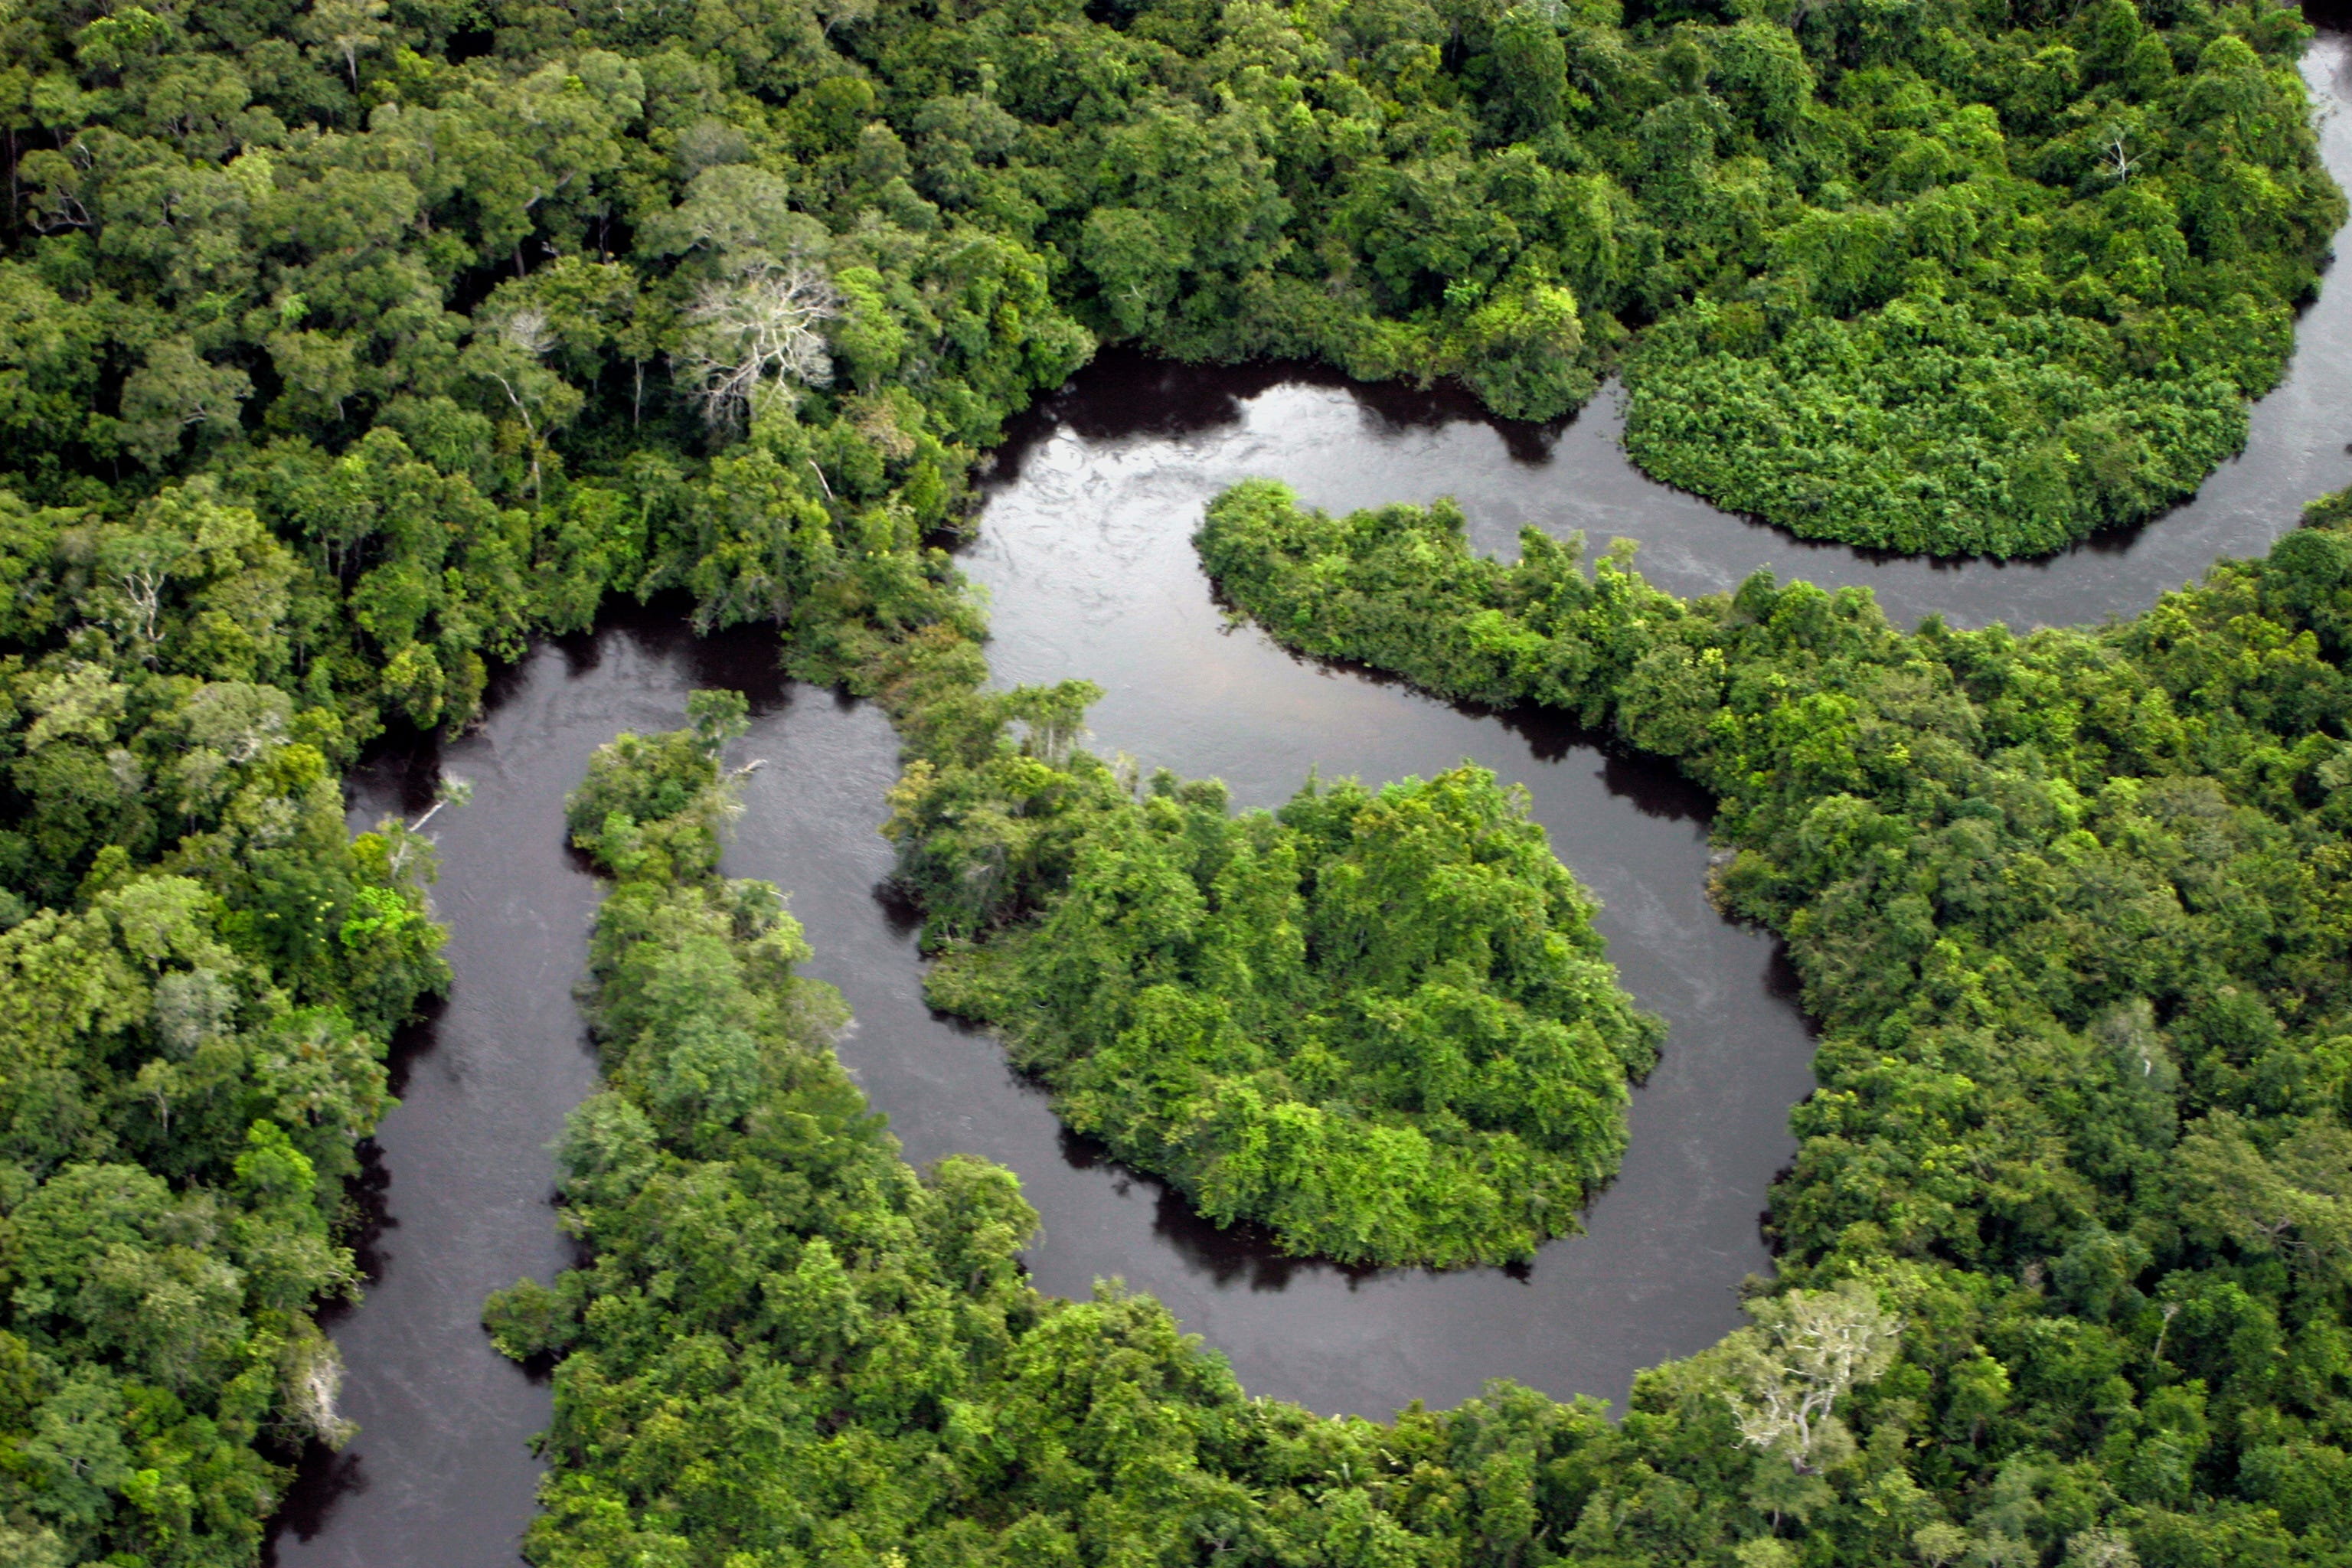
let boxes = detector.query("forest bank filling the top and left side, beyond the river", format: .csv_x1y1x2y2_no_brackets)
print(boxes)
0,0,2341,1563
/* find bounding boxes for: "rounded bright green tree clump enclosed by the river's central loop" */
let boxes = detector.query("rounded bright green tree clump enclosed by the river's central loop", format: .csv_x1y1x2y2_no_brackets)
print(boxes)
884,743,1658,1265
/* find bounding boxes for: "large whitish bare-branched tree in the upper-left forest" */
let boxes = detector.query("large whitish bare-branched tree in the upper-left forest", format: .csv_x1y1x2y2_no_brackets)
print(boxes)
680,252,842,428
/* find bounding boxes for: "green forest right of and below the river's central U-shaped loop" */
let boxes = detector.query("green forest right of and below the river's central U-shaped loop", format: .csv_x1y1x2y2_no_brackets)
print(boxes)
468,462,2352,1568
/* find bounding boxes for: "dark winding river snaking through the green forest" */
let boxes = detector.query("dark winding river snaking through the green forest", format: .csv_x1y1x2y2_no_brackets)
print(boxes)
275,33,2352,1568
